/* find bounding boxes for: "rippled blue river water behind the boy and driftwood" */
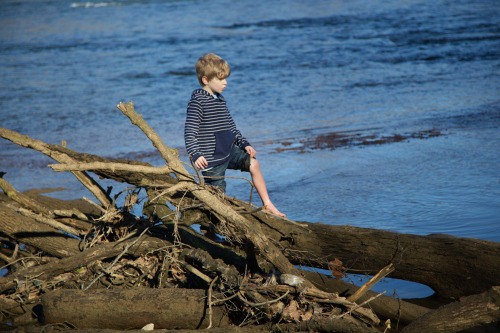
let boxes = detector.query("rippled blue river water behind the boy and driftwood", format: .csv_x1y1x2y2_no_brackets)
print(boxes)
0,0,500,296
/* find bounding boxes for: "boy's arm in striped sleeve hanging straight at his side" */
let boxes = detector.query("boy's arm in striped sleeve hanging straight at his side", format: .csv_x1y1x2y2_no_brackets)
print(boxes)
184,99,203,164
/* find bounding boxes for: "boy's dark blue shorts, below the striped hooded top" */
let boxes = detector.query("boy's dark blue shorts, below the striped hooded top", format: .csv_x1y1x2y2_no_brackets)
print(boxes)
202,146,250,192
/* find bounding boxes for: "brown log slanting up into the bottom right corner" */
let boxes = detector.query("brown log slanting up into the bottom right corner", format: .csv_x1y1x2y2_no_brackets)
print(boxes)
402,286,500,333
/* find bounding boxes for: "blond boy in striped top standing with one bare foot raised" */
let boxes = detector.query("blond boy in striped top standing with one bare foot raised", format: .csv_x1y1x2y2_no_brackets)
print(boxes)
184,53,285,217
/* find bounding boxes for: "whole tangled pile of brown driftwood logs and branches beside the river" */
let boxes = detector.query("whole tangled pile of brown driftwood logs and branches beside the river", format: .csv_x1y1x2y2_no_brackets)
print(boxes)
0,103,500,332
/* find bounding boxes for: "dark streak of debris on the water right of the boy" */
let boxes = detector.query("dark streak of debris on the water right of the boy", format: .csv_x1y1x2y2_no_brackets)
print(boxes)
270,128,443,153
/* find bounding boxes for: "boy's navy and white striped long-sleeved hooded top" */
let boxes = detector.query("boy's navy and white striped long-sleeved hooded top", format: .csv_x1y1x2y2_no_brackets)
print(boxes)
184,89,250,168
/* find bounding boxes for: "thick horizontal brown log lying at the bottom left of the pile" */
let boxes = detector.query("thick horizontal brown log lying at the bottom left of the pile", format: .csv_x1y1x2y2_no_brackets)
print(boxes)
42,288,228,329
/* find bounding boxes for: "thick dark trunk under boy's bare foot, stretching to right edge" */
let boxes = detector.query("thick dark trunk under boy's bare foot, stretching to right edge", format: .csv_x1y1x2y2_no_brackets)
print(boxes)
254,213,500,300
